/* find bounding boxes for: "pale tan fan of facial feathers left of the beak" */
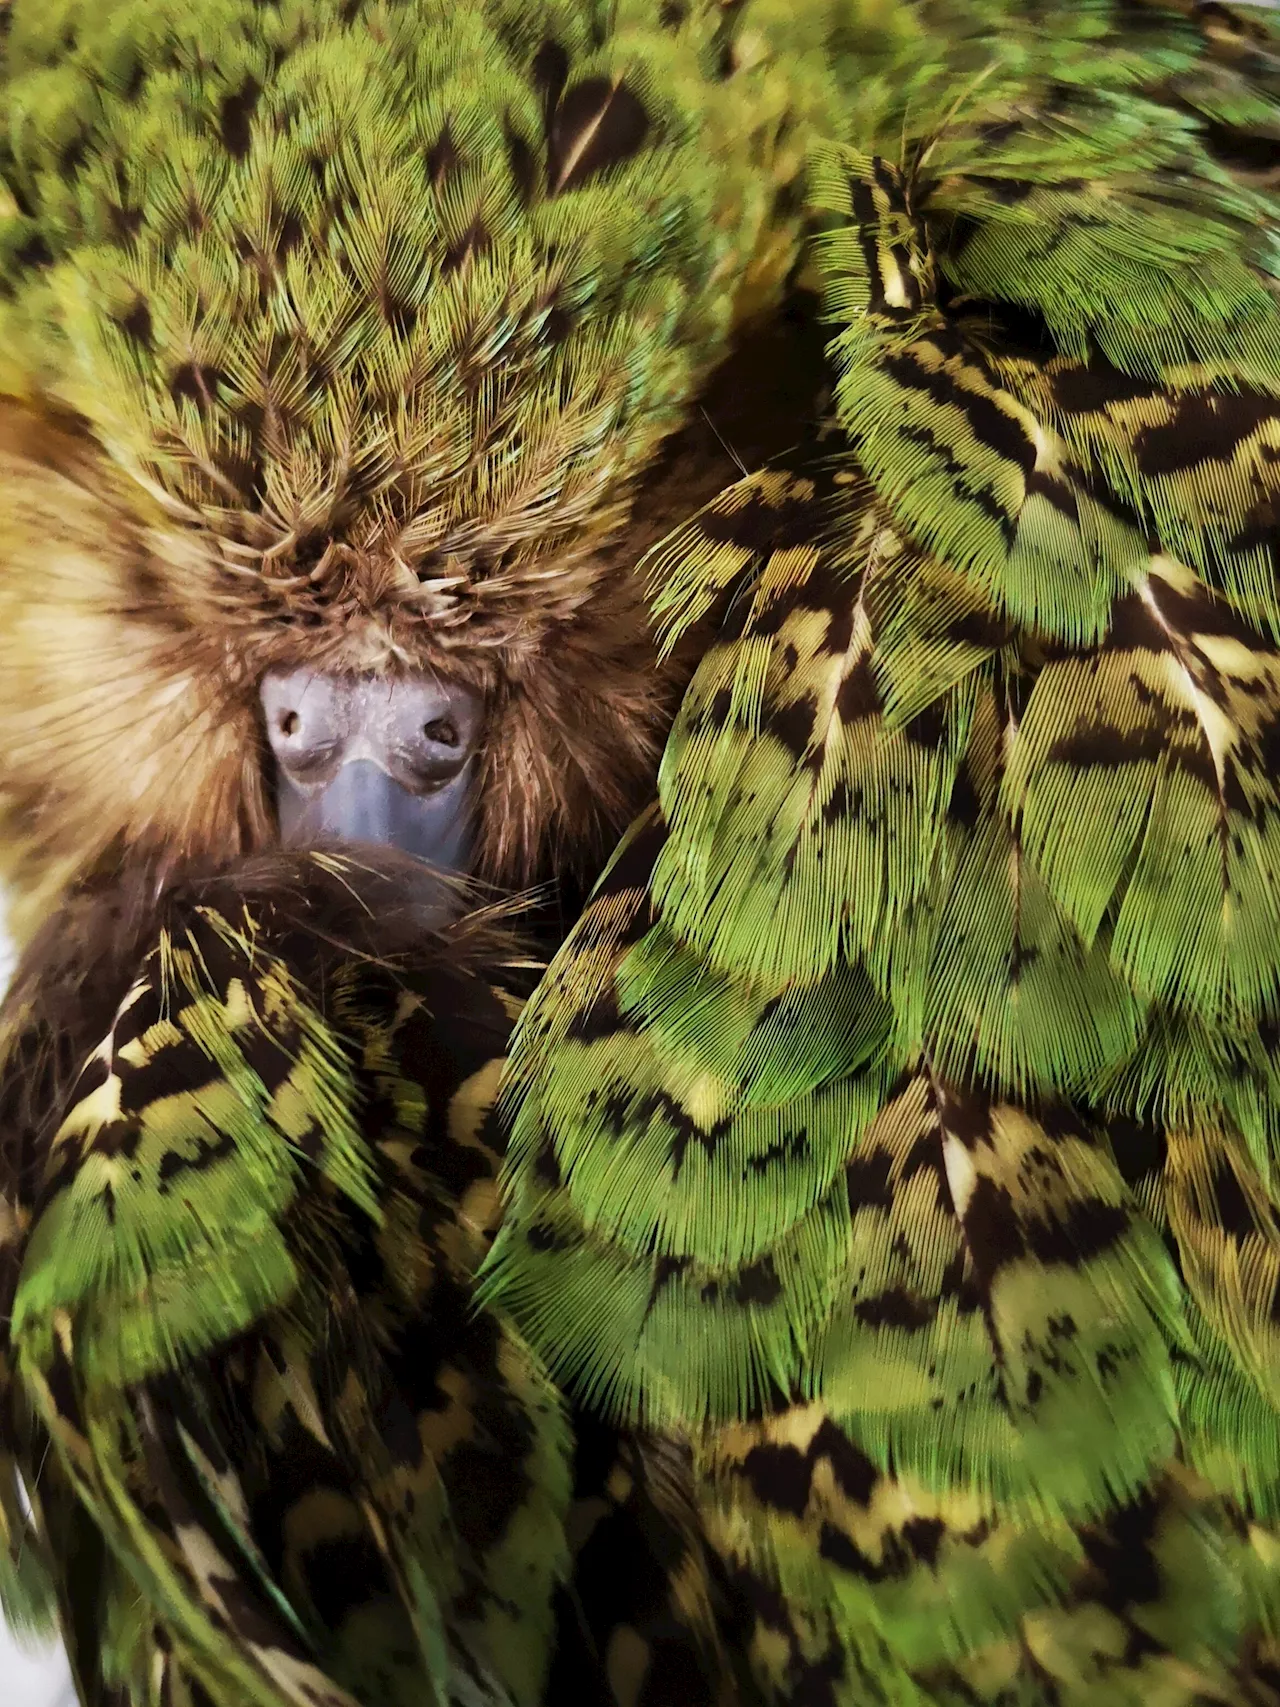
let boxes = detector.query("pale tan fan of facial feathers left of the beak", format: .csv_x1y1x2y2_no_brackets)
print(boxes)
0,403,270,939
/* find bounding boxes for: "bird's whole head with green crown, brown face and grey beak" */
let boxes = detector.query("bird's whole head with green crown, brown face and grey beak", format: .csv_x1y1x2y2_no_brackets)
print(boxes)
0,0,843,935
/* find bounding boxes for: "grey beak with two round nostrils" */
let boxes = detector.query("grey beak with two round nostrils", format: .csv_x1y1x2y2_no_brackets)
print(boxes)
261,669,483,874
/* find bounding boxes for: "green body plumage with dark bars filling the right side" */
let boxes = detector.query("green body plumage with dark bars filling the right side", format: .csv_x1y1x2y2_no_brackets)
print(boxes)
486,5,1280,1707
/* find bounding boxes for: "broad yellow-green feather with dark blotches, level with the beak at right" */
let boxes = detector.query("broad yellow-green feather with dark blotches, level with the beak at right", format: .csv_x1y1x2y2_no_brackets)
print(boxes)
654,481,983,988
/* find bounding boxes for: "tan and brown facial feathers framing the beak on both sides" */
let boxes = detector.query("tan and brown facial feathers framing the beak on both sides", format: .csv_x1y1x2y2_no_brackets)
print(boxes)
0,314,823,941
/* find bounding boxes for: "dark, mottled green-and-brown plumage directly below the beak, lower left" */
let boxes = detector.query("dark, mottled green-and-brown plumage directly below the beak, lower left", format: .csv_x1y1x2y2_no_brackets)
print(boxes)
5,857,570,1707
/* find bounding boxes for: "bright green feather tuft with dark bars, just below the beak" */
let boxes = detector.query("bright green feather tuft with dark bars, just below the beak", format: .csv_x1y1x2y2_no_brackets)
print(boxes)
12,920,377,1386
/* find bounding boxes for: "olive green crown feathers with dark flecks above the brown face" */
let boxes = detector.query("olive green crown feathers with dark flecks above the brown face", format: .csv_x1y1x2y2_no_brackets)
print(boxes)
0,0,821,587
